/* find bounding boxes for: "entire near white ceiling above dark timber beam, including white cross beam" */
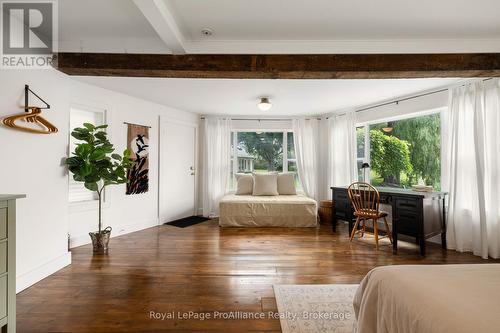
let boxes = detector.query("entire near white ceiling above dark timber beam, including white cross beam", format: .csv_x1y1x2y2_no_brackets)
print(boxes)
58,0,500,53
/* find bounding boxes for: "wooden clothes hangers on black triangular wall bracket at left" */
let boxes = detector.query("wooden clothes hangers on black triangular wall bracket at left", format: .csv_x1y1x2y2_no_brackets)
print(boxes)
3,85,58,134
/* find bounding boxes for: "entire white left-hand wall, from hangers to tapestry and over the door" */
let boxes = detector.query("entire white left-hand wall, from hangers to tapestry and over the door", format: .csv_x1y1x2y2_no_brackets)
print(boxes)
0,70,198,291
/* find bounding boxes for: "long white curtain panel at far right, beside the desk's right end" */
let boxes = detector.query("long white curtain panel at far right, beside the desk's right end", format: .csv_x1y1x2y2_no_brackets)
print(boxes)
442,79,500,259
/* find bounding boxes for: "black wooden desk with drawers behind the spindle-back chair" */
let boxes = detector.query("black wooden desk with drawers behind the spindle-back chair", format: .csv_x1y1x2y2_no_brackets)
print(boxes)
331,186,446,255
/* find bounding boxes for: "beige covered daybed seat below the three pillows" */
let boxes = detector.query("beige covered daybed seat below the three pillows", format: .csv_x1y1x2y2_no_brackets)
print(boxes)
219,194,317,227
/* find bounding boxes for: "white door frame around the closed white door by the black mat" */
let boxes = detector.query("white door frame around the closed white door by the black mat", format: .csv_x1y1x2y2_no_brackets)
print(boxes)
158,116,200,225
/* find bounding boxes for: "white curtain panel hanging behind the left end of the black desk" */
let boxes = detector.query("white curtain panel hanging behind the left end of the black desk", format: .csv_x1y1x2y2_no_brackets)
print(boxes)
327,111,358,186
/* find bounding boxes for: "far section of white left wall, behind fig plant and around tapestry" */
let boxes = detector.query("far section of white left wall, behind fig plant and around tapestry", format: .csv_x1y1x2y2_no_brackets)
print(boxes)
69,81,199,247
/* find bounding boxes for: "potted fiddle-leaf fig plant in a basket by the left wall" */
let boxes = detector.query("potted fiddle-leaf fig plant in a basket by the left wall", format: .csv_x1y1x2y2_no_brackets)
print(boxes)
65,123,133,253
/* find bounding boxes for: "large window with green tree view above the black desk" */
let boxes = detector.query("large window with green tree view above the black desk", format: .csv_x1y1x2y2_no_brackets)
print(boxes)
356,113,441,190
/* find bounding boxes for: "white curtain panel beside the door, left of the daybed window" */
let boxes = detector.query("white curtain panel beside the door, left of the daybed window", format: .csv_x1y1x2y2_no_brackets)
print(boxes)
202,117,231,217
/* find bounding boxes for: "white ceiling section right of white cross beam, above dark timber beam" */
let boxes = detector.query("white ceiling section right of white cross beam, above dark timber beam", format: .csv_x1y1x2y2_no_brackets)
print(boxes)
169,0,500,40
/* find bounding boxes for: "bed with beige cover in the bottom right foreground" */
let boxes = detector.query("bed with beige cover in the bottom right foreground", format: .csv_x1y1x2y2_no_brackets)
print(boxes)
354,264,500,333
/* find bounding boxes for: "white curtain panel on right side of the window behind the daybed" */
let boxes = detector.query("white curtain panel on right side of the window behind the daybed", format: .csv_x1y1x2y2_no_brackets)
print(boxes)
293,118,320,200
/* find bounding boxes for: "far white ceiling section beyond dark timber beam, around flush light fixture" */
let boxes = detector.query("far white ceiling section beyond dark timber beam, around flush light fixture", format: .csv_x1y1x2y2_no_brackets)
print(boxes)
76,77,458,117
